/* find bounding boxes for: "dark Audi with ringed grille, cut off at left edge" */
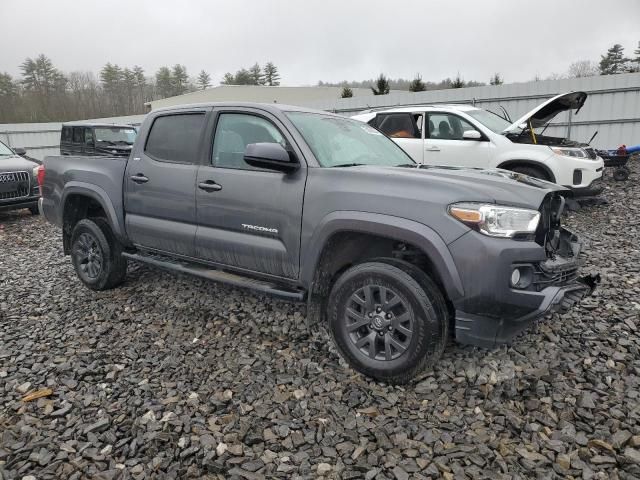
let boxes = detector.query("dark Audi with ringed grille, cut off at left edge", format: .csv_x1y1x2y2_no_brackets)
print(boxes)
0,142,44,215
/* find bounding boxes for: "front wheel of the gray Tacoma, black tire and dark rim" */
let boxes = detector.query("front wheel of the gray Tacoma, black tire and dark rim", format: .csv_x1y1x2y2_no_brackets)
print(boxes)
327,261,449,384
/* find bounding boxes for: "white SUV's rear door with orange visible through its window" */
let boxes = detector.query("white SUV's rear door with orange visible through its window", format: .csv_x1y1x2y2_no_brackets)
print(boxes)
376,112,424,163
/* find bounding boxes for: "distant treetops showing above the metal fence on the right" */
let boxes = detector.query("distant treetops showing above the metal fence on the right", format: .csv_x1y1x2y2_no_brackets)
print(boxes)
328,42,640,98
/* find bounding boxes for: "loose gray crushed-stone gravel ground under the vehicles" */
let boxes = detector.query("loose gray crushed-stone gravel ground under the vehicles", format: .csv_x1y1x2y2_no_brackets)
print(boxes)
0,165,640,480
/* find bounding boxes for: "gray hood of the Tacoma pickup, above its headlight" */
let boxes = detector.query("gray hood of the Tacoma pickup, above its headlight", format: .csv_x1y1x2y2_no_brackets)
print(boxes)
350,165,569,209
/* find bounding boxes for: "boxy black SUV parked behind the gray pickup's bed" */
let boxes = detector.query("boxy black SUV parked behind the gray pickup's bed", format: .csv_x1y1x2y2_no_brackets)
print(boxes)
60,122,137,157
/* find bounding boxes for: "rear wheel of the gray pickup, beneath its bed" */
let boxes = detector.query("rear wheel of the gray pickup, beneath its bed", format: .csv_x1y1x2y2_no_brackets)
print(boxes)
71,218,127,291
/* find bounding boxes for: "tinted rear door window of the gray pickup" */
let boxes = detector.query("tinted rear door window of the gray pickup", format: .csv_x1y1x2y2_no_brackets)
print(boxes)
144,113,205,163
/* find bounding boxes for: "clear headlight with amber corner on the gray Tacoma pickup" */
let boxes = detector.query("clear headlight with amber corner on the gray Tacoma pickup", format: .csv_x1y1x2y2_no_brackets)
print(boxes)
449,203,540,238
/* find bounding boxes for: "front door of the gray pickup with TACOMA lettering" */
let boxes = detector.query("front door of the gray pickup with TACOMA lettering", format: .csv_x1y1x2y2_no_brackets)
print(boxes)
195,108,306,278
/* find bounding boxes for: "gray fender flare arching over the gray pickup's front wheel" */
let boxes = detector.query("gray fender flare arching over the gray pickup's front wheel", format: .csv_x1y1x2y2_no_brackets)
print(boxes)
300,210,464,300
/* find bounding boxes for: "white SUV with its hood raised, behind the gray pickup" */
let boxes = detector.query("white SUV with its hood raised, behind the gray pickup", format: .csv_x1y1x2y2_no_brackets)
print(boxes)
352,92,604,195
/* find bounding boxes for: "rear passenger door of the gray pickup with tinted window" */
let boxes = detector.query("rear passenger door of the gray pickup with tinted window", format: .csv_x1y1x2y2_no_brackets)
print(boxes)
124,109,207,257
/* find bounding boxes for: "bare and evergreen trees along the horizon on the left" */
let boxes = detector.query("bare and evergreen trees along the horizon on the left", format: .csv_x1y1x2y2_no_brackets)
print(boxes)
0,54,280,123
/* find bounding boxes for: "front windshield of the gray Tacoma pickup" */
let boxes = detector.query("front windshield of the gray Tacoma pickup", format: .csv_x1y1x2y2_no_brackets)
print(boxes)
286,112,414,167
